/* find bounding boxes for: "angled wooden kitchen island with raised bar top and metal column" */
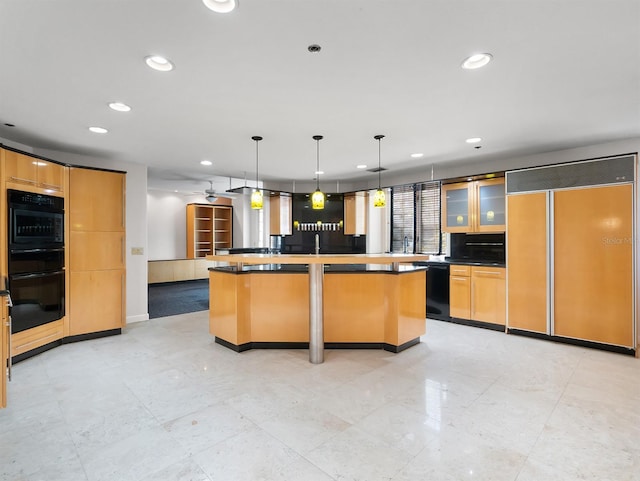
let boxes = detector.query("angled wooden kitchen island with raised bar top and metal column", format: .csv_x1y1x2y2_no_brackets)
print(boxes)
207,254,428,363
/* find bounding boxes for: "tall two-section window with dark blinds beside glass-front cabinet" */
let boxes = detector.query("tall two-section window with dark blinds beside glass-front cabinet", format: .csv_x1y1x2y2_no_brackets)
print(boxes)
391,181,441,254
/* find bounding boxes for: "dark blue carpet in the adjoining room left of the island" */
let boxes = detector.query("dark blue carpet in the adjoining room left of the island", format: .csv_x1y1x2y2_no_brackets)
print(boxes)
149,279,209,319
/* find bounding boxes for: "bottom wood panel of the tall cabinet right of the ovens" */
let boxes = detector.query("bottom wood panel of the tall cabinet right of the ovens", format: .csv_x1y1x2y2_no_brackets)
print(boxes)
69,270,125,336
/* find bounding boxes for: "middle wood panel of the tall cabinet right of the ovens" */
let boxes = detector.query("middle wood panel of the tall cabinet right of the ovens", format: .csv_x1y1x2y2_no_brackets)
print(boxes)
69,231,125,271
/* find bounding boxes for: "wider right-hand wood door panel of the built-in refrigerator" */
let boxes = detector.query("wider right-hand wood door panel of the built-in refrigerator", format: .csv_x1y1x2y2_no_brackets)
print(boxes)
553,185,634,346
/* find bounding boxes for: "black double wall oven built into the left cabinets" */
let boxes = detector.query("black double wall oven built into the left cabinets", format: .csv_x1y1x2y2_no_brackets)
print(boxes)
7,190,65,334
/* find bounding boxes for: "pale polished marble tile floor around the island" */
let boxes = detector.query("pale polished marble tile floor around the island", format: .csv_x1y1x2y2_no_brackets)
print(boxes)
0,311,640,481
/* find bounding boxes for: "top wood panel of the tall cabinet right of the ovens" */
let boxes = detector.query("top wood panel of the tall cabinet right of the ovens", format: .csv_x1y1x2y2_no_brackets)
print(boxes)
69,167,125,232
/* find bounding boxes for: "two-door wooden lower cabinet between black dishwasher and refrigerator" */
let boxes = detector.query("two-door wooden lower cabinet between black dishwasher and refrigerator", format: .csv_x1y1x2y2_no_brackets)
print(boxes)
449,265,506,325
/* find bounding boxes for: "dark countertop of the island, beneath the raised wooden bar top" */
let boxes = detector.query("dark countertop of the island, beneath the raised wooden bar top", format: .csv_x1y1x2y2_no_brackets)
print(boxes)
209,264,426,274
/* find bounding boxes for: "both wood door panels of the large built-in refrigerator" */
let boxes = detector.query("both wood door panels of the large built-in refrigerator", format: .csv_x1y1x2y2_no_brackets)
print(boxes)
507,184,635,347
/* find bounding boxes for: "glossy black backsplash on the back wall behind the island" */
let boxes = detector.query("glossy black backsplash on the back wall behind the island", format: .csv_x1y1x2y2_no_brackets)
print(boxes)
279,194,367,254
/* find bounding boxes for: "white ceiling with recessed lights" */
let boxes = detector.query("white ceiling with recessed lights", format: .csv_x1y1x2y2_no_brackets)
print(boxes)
0,0,640,195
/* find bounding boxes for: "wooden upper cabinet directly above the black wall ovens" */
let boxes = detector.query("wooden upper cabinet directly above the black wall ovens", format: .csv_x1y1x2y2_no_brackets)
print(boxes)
3,149,65,195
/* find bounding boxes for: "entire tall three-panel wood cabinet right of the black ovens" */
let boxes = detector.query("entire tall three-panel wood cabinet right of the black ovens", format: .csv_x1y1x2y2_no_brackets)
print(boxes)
67,167,126,336
